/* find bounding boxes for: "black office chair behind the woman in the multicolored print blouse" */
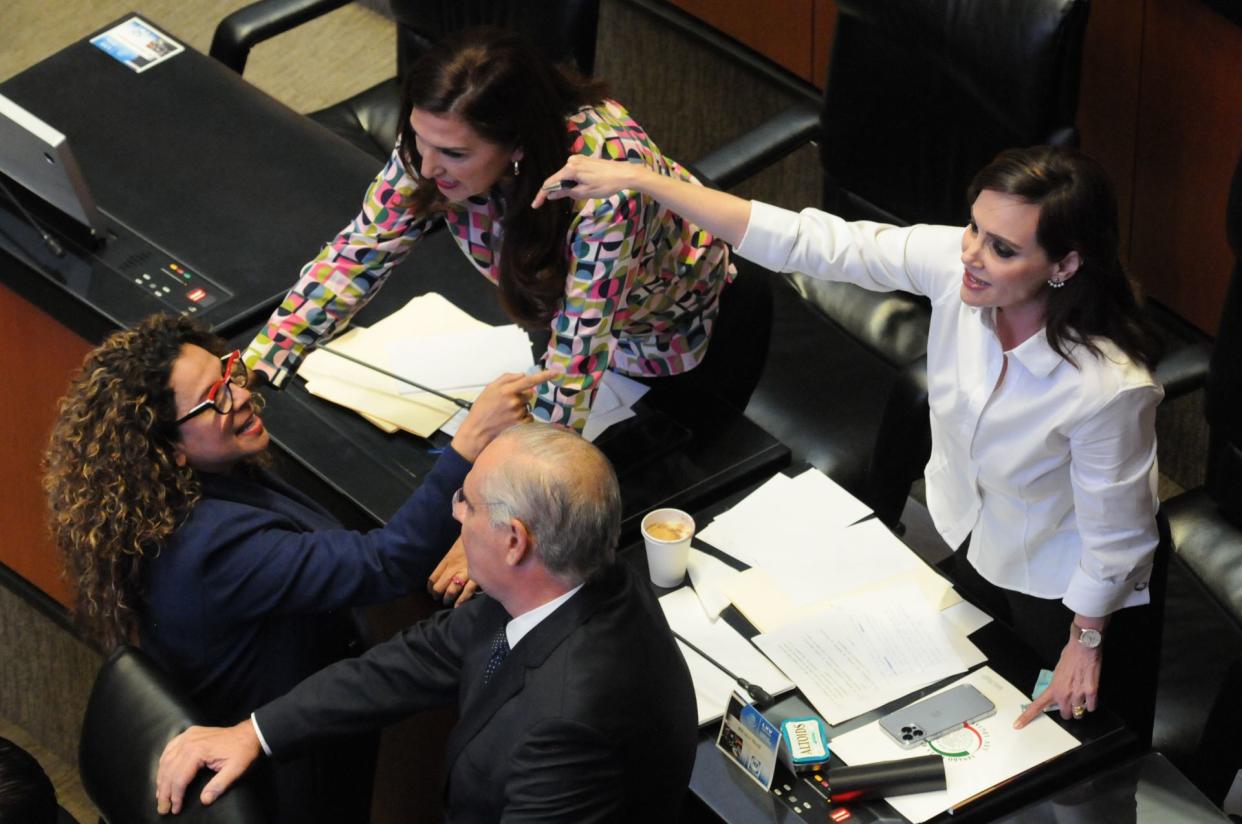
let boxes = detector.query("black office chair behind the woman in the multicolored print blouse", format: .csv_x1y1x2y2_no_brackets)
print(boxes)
210,0,599,160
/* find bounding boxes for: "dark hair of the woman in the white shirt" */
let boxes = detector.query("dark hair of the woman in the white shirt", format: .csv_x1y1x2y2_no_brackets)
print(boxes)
968,145,1160,369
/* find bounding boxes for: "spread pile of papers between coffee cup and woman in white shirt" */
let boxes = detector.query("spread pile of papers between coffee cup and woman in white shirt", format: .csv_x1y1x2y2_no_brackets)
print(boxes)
696,470,989,723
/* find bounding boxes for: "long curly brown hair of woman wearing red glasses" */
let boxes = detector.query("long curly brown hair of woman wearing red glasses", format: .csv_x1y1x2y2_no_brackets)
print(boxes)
43,316,225,649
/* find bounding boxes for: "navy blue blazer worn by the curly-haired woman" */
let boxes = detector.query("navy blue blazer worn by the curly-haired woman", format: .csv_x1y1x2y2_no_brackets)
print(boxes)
140,449,469,725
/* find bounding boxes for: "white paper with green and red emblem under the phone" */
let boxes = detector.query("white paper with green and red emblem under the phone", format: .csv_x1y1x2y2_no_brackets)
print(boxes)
831,666,1078,824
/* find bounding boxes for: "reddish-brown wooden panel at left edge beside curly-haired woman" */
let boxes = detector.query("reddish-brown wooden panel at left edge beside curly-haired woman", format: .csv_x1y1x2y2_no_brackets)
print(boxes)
0,280,91,607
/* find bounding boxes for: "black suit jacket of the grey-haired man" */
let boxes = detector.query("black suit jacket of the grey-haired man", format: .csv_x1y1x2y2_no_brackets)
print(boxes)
256,564,698,823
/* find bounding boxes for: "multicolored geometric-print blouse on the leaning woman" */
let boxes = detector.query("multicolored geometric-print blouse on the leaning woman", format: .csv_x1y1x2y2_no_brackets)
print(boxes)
245,101,732,430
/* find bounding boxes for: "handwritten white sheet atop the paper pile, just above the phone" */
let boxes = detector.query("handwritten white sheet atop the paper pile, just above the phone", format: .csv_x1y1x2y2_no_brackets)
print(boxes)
755,584,965,725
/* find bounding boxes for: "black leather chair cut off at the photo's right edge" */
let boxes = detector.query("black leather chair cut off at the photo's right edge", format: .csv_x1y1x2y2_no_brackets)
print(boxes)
1155,149,1242,803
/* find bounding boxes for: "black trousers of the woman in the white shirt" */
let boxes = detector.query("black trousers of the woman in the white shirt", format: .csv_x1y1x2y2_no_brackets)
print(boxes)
943,516,1171,747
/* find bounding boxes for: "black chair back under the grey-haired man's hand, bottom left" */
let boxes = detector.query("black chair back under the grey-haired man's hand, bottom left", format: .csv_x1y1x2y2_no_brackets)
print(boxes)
78,646,268,824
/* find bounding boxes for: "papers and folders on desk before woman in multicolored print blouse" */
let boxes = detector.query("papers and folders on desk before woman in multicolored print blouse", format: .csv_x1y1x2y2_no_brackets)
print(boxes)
298,293,534,437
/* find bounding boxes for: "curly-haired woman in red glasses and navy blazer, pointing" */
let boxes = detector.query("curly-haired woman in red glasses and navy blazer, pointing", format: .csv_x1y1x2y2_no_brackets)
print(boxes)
43,316,546,822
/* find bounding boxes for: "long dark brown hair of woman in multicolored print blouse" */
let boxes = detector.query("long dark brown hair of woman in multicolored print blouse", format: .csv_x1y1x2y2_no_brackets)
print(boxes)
401,29,605,326
